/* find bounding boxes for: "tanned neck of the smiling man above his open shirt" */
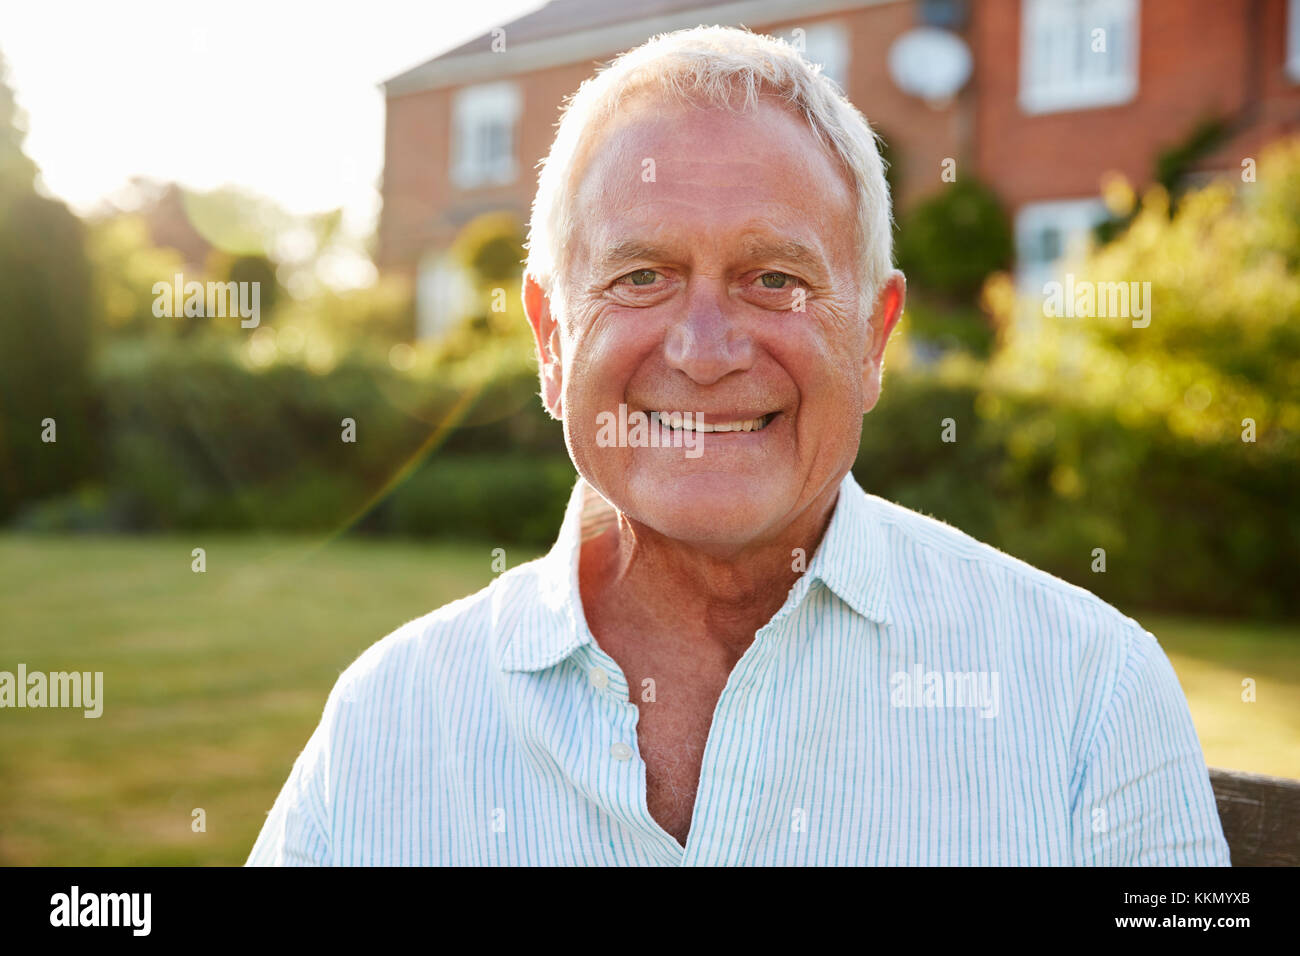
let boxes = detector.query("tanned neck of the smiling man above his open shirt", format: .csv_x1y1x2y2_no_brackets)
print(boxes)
579,485,839,661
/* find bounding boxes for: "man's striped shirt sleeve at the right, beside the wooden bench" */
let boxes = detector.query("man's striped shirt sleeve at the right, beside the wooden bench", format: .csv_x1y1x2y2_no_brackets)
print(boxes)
1071,626,1231,866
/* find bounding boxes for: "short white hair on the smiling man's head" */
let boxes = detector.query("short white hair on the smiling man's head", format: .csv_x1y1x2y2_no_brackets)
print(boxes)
525,26,893,319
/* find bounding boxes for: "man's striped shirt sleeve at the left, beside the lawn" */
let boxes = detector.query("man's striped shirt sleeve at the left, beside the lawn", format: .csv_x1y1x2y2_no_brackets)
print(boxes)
244,698,333,866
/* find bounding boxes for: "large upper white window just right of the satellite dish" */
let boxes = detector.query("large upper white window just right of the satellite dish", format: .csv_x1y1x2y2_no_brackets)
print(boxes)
1019,0,1141,114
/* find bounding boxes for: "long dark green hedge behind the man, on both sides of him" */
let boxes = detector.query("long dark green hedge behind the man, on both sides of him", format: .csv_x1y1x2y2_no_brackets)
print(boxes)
7,340,1300,617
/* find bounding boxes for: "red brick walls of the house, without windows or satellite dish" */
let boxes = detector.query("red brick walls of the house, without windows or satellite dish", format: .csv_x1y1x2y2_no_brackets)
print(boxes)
380,0,1300,277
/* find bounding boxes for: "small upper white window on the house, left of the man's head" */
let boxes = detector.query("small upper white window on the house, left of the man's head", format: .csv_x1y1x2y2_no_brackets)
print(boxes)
450,81,523,189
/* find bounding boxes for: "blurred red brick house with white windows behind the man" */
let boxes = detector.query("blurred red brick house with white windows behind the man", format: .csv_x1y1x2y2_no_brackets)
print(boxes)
377,0,1300,336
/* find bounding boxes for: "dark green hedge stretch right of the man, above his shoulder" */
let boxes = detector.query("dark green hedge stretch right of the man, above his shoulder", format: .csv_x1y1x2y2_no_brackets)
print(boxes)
854,366,1300,617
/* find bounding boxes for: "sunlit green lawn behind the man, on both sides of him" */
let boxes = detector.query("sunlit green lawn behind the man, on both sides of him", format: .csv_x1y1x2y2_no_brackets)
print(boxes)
0,535,1300,865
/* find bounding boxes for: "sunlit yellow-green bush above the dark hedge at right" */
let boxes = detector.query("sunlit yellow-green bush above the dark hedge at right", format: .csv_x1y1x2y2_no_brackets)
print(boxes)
993,138,1300,450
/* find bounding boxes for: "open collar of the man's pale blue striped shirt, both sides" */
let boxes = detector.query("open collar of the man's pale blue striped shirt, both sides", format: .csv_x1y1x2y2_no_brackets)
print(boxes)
493,471,889,671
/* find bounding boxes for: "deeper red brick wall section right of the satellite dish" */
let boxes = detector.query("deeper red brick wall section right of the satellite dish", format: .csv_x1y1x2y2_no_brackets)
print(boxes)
971,0,1300,208
